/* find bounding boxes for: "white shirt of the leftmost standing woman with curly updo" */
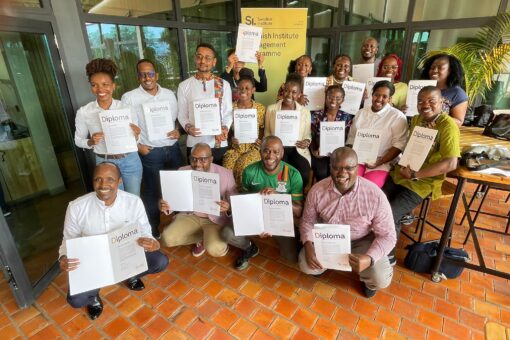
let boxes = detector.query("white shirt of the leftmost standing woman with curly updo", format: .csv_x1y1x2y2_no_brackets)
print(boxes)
74,99,138,155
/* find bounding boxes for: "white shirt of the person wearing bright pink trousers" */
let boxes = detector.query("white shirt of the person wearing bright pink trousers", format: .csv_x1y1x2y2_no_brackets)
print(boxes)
345,104,408,171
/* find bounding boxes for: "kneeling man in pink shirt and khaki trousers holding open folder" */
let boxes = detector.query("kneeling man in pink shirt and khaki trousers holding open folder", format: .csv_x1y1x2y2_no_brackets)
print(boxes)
160,143,237,257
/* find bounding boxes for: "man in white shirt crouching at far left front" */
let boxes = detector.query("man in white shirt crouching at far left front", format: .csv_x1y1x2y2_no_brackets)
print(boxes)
59,162,168,320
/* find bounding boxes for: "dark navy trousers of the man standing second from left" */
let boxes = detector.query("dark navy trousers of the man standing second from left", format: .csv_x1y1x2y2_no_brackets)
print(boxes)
140,143,182,235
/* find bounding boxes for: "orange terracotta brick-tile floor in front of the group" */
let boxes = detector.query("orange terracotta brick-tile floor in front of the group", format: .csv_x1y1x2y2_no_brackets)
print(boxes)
0,182,510,339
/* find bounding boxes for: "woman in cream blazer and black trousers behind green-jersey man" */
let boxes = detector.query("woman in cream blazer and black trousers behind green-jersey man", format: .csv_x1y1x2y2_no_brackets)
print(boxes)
264,73,312,187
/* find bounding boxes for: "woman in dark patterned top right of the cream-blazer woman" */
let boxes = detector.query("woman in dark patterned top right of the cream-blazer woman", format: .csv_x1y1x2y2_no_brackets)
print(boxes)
310,84,352,181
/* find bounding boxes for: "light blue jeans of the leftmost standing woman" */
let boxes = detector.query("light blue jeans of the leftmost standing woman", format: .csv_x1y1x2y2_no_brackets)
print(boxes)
96,152,142,196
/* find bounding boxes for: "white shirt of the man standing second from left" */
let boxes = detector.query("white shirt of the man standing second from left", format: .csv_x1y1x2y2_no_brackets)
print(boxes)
121,85,178,147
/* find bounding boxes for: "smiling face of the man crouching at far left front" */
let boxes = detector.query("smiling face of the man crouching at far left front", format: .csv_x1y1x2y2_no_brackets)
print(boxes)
93,163,122,206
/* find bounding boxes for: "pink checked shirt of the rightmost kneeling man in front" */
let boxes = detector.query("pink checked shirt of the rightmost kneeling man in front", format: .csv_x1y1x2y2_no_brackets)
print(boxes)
300,177,397,262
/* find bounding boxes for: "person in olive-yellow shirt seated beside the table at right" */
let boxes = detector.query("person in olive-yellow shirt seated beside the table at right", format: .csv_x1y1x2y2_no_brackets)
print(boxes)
382,86,460,264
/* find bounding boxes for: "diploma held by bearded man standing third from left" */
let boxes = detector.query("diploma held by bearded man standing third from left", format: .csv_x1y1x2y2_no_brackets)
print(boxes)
193,98,221,136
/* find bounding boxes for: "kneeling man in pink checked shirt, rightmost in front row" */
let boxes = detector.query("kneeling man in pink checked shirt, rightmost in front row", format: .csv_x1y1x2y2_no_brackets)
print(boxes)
299,147,396,298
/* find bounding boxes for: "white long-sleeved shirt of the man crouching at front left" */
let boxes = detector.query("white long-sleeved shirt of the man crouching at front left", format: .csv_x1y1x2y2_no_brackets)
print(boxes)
58,190,153,258
